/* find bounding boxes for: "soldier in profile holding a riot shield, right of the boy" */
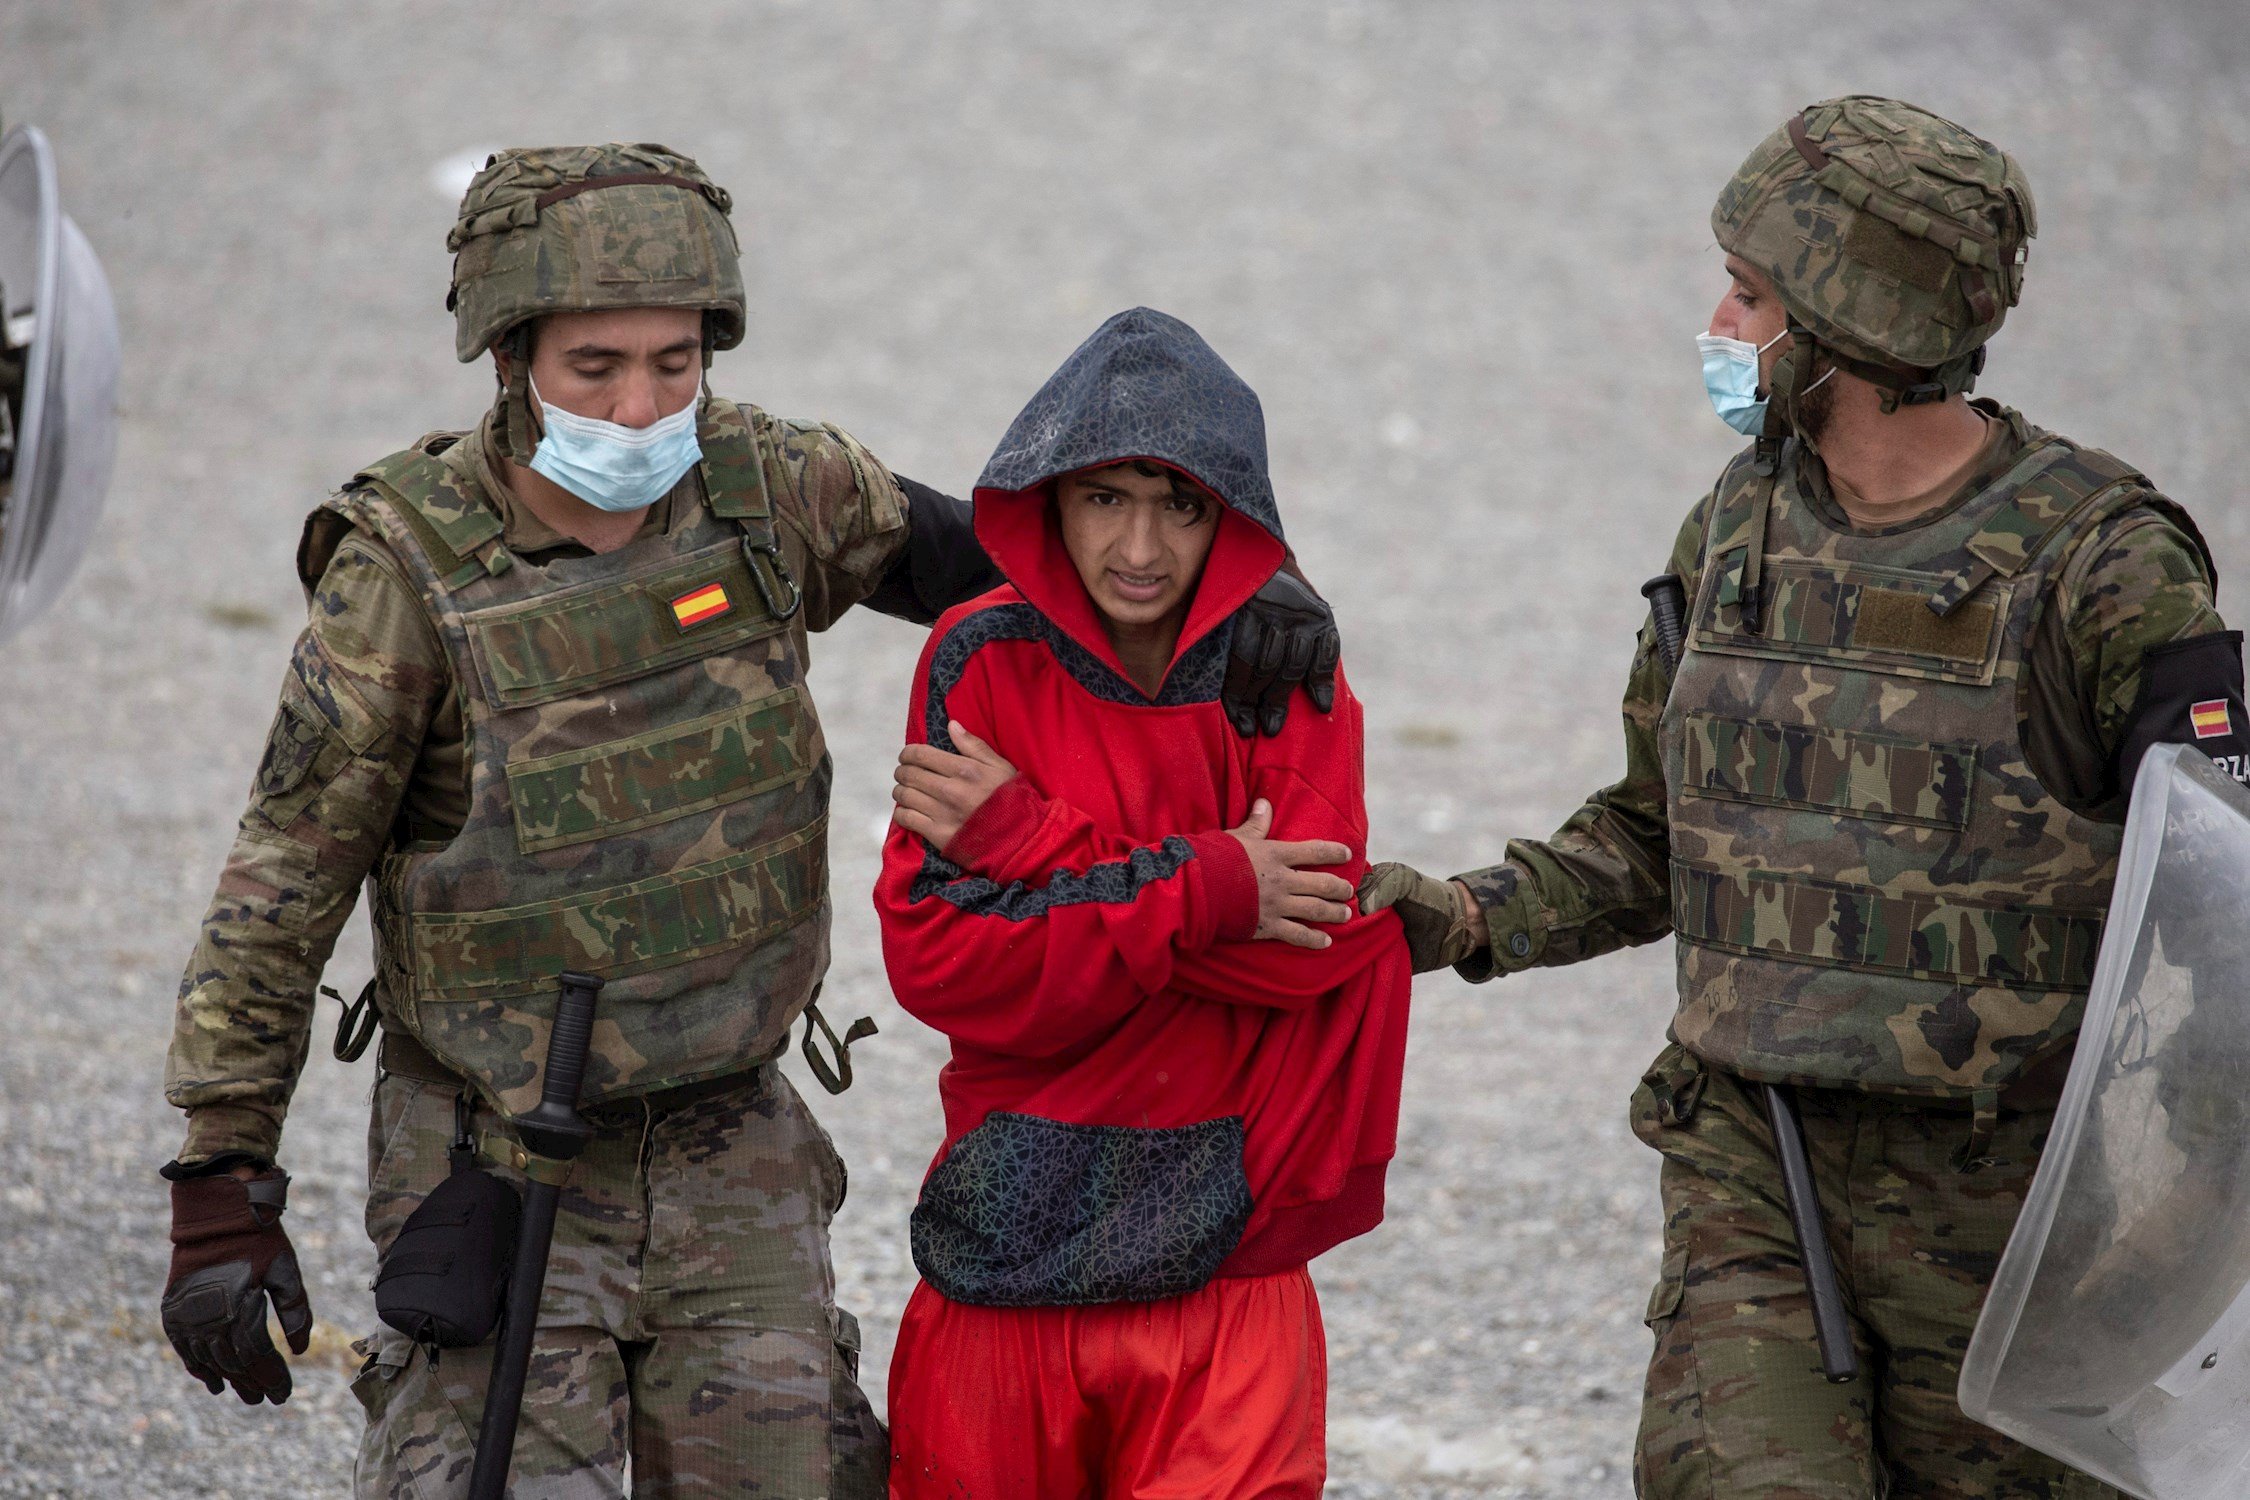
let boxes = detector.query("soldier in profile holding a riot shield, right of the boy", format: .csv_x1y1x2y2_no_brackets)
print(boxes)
1361,97,2243,1500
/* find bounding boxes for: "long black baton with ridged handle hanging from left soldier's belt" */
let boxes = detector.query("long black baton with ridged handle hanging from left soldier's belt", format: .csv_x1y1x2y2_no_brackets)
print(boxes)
468,974,601,1500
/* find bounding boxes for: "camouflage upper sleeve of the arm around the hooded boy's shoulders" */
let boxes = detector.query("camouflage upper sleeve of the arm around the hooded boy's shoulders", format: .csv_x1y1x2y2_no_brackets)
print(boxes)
767,418,907,630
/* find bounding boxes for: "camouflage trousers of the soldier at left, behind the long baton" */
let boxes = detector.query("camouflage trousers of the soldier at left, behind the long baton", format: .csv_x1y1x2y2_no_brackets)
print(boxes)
353,1066,889,1500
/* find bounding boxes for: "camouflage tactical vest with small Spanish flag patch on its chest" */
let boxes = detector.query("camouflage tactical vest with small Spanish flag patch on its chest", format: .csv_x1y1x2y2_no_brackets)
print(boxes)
329,398,830,1115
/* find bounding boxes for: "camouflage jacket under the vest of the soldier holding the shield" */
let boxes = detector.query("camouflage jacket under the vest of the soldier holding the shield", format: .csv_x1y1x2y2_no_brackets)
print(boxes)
1458,400,2225,981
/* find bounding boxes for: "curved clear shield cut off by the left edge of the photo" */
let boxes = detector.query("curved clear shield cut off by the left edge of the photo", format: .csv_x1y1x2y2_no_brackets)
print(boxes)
0,126,117,641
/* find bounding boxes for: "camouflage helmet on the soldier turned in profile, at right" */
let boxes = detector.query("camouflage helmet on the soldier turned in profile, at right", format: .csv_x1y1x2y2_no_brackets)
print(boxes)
1710,94,2039,409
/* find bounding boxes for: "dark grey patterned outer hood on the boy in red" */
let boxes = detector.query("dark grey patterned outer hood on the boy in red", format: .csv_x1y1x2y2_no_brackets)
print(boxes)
977,308,1287,541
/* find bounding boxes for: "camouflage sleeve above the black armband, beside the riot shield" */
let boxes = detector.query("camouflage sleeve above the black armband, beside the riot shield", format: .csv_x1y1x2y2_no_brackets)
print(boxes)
2023,506,2225,819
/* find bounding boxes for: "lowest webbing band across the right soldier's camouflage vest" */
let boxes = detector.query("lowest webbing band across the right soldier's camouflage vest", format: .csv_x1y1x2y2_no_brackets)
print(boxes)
1672,861,2102,992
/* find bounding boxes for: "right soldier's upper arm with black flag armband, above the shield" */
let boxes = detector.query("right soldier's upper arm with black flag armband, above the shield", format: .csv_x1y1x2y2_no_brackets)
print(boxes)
2027,504,2250,814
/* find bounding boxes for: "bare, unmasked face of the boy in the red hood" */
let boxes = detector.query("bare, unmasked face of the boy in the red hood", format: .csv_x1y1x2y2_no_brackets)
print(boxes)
1055,461,1220,625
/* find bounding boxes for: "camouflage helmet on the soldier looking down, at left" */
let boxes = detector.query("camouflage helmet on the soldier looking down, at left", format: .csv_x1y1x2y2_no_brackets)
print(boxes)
446,142,745,364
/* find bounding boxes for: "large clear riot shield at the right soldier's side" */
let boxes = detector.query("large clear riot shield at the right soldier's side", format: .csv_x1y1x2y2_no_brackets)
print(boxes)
1960,744,2250,1500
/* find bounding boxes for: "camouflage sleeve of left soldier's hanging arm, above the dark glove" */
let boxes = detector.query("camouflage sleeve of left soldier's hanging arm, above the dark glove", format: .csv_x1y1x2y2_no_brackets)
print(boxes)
164,535,448,1165
